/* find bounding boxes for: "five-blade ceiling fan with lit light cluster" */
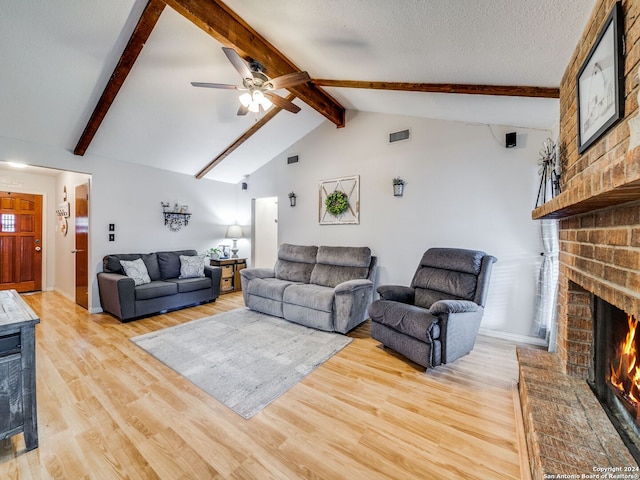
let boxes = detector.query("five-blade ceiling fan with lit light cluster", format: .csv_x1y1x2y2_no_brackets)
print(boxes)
191,47,311,115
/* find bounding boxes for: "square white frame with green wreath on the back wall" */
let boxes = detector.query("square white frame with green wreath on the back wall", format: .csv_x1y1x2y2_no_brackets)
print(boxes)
318,175,360,225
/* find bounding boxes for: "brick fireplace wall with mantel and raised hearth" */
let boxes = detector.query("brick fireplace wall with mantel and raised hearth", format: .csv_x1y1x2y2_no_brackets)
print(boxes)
518,0,640,478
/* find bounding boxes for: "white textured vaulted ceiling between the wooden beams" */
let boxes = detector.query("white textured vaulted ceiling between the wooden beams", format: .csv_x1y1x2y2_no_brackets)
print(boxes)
0,0,595,183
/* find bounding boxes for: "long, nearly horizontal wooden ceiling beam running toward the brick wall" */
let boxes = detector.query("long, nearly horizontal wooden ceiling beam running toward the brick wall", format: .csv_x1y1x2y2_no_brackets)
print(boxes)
311,79,560,98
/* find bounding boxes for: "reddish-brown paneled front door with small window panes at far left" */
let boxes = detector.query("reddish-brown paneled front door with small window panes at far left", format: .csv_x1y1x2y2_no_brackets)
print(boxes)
0,192,42,292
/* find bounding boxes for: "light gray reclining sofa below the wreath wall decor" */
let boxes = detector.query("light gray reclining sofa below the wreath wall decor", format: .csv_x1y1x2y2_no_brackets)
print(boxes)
240,244,376,333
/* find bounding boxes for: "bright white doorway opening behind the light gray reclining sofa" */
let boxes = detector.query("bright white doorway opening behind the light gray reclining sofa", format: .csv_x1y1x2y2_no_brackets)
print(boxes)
251,197,278,268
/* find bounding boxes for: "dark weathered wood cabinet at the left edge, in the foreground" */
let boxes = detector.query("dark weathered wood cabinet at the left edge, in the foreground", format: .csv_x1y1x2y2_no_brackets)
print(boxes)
0,290,40,450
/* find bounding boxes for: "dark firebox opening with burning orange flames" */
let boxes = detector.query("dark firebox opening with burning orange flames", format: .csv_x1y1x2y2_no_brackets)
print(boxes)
589,297,640,464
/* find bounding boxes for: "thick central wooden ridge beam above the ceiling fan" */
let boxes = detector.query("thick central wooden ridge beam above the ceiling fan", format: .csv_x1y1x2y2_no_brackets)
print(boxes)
164,0,345,127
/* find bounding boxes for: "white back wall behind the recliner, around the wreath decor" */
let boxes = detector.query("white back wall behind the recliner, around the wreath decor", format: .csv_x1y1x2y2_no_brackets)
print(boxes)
241,113,551,335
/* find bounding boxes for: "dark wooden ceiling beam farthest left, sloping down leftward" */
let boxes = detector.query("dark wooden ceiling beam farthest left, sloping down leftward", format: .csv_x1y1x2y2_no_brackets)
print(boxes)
73,0,165,156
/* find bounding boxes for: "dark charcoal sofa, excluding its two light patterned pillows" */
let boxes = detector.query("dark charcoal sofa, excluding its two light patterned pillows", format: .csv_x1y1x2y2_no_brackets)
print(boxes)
98,250,222,322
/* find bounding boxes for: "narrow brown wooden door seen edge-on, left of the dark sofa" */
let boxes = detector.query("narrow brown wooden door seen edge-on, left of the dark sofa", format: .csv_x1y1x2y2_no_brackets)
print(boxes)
75,183,89,309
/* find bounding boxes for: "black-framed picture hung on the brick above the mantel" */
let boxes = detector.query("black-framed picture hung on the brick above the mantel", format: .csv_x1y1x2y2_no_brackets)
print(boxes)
576,2,624,153
